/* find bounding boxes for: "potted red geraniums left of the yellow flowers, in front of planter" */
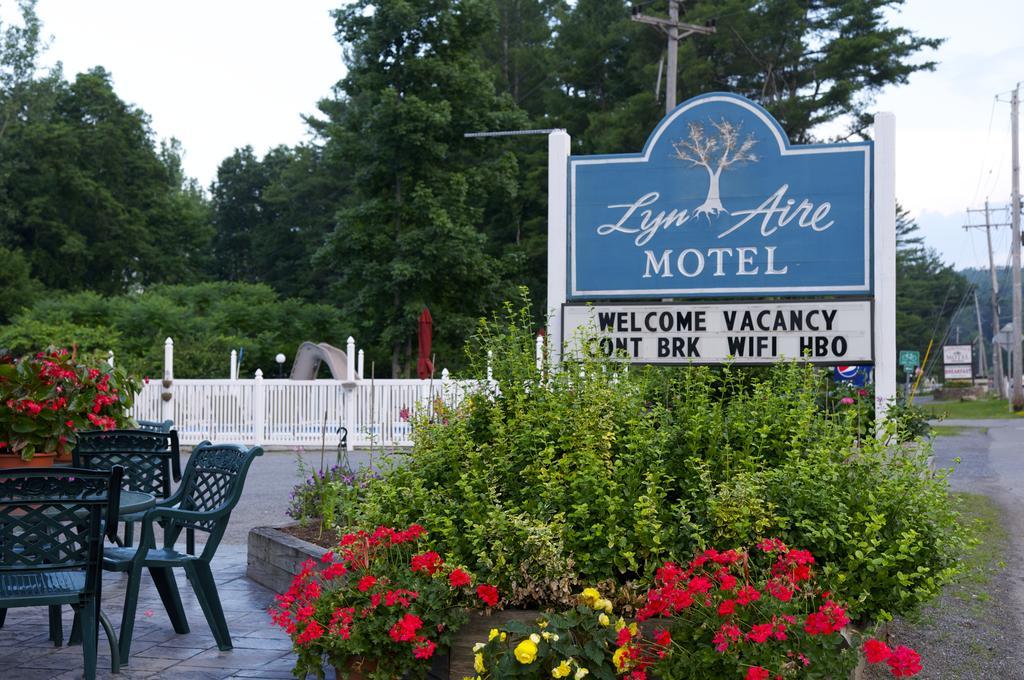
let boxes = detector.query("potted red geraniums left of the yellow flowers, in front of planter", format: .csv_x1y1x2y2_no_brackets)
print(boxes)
270,524,499,680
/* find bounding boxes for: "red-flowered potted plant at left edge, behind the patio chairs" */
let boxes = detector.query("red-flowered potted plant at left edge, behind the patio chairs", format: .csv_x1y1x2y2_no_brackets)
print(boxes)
0,349,136,467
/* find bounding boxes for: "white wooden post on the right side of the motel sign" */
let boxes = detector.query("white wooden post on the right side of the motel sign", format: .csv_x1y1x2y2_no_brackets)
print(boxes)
874,113,896,426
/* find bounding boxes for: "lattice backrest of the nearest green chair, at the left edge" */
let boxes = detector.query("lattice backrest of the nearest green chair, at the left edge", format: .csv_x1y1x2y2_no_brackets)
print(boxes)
0,467,123,577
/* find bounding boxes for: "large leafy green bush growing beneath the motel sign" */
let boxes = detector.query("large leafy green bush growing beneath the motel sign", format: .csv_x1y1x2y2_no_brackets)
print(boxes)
346,296,965,620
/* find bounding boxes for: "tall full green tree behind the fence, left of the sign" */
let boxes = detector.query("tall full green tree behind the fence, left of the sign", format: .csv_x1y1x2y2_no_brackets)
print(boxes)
318,0,525,377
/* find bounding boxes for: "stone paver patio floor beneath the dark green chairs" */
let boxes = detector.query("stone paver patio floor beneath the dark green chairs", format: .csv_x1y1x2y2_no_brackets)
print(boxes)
0,545,303,680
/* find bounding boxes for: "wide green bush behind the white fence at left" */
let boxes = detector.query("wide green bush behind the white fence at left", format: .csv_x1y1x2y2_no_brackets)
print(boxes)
0,282,348,378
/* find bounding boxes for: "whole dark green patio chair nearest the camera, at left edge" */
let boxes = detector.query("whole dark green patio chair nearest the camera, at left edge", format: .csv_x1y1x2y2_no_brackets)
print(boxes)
0,466,124,680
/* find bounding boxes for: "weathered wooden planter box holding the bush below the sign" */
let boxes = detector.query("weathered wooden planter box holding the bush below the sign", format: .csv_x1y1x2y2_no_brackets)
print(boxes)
246,526,540,680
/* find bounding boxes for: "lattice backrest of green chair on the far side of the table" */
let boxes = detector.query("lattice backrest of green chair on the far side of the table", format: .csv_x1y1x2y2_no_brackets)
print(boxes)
72,430,181,499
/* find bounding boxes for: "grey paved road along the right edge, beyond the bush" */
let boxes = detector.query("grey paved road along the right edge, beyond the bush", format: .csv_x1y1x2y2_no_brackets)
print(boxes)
935,419,1024,626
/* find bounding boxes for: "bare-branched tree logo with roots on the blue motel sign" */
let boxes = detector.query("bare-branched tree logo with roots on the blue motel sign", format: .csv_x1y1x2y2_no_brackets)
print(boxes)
672,118,758,217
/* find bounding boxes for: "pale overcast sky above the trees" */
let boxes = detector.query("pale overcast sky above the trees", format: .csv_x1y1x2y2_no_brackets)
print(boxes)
14,0,1024,266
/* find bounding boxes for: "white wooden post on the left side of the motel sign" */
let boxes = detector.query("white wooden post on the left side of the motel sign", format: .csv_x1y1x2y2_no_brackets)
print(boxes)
547,130,571,366
